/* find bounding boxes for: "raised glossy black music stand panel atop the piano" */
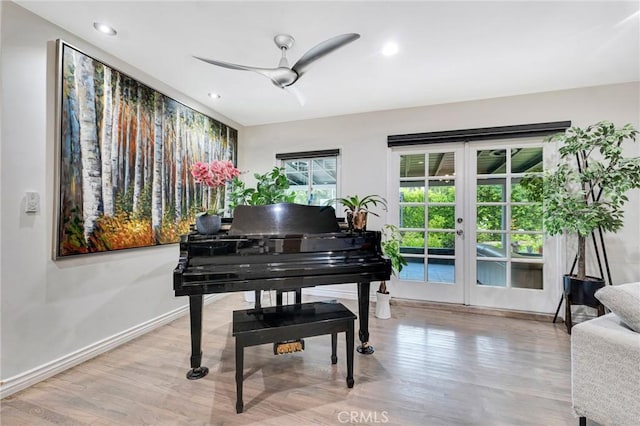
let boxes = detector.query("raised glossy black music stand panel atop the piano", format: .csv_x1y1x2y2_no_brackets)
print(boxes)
229,203,340,235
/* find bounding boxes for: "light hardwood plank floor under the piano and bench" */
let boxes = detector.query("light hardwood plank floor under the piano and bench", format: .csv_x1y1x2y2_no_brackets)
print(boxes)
0,294,578,426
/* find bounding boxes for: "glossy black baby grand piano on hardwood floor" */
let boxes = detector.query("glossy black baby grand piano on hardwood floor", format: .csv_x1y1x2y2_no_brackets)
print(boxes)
173,203,391,380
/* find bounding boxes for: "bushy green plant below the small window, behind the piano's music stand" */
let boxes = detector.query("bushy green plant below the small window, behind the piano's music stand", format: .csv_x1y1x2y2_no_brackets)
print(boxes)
229,167,296,211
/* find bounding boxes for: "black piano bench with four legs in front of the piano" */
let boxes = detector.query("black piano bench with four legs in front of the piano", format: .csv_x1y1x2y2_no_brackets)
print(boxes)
233,302,356,413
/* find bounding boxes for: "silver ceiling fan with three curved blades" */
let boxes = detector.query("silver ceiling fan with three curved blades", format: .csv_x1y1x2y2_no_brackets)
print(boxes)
194,33,360,89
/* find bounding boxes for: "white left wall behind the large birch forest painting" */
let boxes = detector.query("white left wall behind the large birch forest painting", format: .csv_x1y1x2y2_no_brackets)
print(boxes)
0,2,242,392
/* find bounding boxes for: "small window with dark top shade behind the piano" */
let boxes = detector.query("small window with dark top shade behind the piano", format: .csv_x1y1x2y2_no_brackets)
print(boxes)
276,149,340,206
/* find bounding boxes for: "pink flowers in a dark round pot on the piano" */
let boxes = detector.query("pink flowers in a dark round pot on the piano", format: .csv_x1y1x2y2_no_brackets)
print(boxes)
191,160,240,234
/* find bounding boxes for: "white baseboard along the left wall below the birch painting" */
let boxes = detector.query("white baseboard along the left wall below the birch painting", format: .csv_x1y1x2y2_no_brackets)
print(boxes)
0,294,226,399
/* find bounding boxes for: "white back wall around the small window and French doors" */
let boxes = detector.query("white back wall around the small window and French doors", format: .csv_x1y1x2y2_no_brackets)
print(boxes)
240,82,640,300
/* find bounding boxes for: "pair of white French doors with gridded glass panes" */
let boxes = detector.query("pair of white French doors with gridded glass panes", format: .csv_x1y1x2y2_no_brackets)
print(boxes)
388,139,560,312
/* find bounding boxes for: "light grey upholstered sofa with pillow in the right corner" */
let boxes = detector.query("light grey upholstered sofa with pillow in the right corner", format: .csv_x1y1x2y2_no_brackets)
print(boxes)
571,283,640,426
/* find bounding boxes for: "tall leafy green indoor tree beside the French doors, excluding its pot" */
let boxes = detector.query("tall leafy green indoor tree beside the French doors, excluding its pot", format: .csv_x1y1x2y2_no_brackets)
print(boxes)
521,121,640,280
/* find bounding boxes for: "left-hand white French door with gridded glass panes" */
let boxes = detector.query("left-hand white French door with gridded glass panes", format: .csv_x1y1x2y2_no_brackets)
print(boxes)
396,144,463,303
